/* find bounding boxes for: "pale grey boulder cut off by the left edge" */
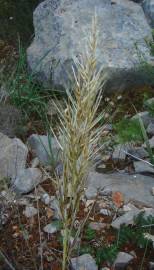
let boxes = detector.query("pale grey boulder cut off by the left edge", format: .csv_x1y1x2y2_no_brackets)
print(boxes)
0,133,28,178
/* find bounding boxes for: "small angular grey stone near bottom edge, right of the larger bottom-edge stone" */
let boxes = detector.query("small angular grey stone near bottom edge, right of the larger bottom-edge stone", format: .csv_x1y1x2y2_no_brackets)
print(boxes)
114,252,134,269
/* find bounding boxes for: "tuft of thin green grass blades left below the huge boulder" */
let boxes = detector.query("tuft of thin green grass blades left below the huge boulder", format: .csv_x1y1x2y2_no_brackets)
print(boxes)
4,42,49,118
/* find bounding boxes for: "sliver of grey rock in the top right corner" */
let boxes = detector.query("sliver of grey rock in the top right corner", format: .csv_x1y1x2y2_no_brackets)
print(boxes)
142,0,154,27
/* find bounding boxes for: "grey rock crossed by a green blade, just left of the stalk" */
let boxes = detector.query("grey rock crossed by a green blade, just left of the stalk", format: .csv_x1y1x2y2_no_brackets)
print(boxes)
27,134,60,165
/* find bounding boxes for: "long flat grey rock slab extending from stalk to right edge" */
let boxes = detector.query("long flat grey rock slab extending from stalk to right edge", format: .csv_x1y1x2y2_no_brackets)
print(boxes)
87,172,154,207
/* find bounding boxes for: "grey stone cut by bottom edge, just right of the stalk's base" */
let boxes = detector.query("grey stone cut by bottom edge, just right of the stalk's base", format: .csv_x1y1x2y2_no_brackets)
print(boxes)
71,254,98,270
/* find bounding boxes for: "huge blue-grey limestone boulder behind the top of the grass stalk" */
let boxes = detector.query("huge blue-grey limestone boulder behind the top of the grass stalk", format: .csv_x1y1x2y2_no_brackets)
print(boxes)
27,0,151,91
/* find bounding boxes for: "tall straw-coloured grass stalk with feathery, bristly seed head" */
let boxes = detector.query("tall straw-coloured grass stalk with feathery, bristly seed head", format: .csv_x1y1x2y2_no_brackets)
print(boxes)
51,17,104,270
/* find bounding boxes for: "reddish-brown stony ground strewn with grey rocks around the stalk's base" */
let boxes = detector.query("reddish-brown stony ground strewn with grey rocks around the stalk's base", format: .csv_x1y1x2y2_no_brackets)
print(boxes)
0,95,154,270
